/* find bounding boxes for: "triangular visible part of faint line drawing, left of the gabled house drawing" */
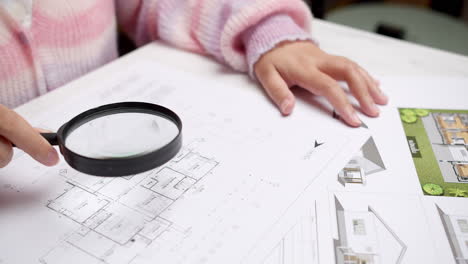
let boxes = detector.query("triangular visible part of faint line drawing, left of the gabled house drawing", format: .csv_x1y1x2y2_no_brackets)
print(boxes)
263,202,319,264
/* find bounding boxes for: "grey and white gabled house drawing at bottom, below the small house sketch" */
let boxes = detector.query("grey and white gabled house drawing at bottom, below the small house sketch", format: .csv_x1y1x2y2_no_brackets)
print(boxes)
334,196,407,264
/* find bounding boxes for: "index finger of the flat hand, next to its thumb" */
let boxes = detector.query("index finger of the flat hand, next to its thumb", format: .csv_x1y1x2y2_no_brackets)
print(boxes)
293,70,361,127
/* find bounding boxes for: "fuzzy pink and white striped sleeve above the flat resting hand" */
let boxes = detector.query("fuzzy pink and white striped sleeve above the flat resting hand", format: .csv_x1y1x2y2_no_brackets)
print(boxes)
116,0,312,72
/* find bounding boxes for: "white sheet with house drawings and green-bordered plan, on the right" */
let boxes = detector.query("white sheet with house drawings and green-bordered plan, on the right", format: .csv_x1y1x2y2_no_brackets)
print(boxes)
246,77,468,264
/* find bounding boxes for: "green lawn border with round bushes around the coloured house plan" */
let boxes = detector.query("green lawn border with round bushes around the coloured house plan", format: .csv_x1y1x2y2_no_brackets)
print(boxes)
400,109,468,197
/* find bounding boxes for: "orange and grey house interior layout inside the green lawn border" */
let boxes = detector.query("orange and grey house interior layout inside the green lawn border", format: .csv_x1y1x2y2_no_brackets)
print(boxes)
422,113,468,183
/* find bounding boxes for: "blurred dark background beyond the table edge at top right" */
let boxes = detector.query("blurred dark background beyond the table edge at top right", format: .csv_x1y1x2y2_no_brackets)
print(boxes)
306,0,468,56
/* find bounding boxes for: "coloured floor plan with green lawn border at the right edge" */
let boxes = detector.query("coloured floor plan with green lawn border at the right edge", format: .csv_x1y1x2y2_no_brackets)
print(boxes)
400,108,468,196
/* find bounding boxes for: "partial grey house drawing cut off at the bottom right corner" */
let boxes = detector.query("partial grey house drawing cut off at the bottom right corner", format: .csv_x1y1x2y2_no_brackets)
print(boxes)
436,205,468,264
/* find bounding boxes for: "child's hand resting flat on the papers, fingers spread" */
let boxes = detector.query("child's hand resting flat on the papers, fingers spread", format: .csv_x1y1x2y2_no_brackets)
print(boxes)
254,42,388,126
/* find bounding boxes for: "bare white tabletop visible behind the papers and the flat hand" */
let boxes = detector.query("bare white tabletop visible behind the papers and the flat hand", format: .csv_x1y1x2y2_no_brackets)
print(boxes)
16,19,468,118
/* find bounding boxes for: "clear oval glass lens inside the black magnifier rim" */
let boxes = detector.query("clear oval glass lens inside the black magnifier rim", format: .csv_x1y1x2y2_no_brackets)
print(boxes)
65,112,179,159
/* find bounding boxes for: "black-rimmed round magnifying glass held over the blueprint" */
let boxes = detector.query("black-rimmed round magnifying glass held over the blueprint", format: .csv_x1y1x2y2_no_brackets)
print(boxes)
25,102,182,177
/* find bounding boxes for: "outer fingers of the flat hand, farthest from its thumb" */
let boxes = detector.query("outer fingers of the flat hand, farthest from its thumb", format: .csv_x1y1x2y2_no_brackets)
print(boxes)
320,56,388,117
